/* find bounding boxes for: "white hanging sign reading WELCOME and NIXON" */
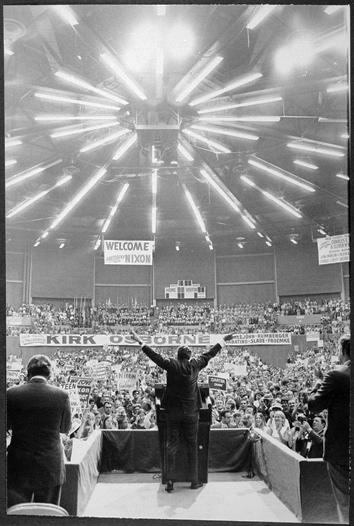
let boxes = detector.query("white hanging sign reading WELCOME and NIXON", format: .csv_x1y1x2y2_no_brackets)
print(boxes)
104,239,154,265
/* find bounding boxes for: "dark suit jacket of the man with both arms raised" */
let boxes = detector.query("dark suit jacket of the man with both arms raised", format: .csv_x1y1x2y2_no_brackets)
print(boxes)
142,343,221,412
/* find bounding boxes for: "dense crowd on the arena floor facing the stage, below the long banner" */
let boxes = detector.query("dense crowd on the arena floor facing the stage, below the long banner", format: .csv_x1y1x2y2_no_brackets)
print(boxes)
8,327,346,464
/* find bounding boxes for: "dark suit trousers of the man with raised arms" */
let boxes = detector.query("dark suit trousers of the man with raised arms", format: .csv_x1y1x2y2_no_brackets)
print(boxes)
166,408,199,482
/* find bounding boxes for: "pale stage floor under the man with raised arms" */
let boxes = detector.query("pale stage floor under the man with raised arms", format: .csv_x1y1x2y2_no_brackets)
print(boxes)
82,473,300,523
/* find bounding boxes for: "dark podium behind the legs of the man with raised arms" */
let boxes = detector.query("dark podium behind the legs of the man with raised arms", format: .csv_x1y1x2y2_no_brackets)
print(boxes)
155,384,211,484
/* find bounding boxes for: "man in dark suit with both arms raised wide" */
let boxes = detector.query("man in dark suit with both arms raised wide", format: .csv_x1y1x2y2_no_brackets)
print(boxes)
131,330,233,492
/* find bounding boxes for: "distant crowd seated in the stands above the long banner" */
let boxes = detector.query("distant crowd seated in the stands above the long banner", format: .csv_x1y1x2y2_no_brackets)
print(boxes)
6,298,350,336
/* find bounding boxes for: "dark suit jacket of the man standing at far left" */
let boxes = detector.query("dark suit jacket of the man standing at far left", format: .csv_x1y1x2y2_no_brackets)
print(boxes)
7,376,71,488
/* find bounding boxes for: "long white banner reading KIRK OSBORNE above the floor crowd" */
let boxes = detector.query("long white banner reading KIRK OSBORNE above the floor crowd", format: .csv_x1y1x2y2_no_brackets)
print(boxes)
20,332,291,347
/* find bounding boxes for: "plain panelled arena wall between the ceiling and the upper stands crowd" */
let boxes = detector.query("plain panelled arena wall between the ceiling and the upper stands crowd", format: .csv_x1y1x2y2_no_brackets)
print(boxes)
6,243,350,306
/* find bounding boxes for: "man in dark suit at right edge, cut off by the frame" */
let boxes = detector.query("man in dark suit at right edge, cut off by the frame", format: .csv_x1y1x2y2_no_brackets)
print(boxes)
308,336,350,523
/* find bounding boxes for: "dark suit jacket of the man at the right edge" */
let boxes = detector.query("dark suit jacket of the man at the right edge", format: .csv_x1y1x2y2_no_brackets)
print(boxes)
308,362,350,465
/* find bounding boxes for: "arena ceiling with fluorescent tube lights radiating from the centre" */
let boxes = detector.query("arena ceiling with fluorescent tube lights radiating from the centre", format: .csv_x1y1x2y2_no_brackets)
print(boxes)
3,4,349,256
